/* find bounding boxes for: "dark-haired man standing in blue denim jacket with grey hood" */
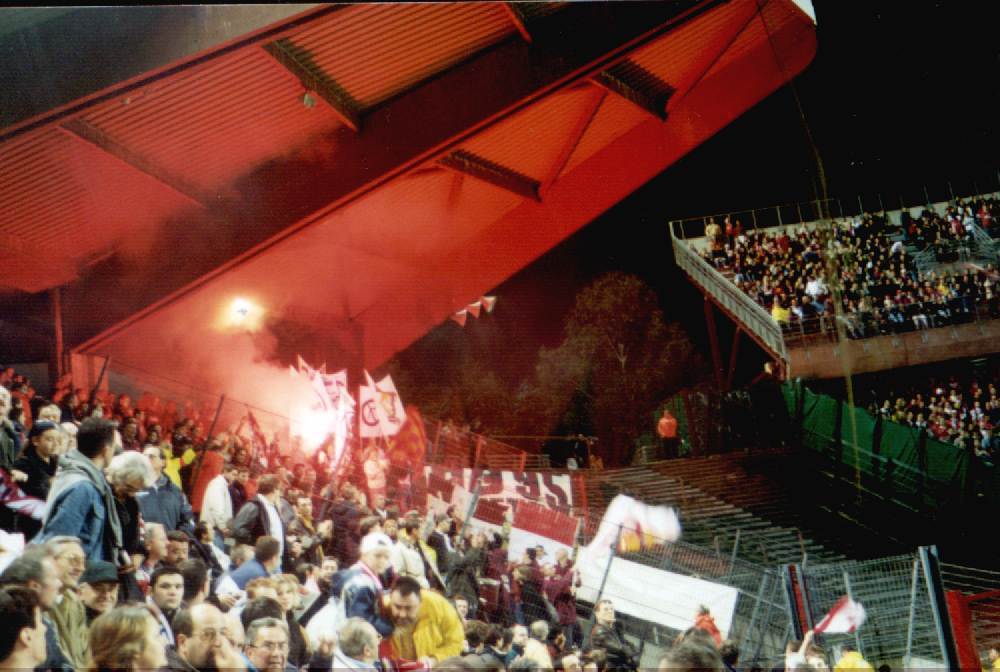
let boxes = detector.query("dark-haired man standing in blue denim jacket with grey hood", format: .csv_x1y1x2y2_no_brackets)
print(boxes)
40,418,123,562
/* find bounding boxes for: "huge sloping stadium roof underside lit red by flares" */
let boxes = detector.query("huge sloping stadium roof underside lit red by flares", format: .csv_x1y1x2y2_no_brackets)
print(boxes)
0,0,816,378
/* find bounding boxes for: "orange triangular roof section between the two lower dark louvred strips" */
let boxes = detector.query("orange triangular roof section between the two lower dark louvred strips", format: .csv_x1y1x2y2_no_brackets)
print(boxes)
462,84,594,182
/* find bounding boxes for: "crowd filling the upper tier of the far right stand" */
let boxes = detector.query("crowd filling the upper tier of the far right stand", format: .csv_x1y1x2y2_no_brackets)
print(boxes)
700,198,1000,338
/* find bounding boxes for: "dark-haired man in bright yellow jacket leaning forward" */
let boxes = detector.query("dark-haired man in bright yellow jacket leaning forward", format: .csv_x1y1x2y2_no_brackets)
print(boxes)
384,576,465,667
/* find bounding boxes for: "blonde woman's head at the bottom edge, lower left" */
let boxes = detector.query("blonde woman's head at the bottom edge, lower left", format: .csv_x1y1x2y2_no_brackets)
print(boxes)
87,605,167,672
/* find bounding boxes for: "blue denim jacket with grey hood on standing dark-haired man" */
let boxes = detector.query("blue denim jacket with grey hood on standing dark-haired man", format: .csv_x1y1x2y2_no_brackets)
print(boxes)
37,449,123,565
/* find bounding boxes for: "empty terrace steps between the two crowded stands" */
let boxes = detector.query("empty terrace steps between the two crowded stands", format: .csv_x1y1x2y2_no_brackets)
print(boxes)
586,450,901,565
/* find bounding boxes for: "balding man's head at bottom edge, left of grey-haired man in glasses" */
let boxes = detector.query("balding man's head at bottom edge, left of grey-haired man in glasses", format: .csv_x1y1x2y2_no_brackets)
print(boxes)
167,604,246,672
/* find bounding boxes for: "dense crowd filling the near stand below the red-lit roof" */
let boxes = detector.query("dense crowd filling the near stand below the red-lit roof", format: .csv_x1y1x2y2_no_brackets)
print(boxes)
0,370,812,672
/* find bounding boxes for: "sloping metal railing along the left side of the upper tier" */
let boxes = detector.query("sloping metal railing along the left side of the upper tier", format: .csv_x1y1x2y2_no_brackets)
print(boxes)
670,223,788,360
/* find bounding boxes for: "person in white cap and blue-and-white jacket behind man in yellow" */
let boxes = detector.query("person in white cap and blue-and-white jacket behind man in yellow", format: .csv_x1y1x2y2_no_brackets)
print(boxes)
332,532,392,637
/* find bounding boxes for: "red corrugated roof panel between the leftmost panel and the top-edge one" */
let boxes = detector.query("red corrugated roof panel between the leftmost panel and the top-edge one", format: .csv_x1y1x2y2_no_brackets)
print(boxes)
79,48,338,191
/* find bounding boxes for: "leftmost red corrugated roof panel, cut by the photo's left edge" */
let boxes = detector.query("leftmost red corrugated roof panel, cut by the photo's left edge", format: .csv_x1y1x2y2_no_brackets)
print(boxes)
0,127,190,259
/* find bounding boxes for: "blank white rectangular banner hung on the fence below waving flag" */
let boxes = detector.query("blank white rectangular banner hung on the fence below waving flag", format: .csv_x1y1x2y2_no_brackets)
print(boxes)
576,548,739,638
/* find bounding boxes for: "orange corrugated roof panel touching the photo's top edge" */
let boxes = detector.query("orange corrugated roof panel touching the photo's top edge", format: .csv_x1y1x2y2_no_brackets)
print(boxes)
289,2,515,109
